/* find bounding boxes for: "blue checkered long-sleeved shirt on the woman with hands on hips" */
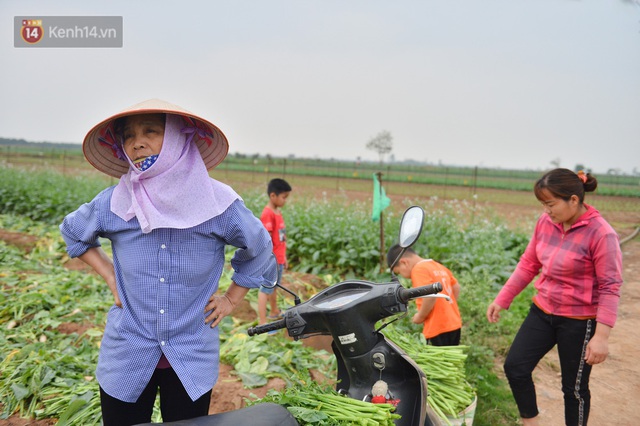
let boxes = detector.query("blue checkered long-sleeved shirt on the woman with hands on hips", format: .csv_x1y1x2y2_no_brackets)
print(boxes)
60,187,276,402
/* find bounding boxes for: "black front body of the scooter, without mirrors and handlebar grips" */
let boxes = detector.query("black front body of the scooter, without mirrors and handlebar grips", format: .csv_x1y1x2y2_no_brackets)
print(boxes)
284,280,441,426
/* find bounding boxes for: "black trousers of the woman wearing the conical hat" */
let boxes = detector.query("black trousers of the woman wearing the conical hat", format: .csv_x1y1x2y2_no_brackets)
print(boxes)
100,368,211,426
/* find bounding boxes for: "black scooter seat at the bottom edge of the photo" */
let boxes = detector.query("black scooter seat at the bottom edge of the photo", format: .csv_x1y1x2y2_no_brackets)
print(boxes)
136,402,298,426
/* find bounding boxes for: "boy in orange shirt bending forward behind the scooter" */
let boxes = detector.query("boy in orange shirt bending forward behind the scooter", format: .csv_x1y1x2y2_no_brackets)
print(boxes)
387,244,462,346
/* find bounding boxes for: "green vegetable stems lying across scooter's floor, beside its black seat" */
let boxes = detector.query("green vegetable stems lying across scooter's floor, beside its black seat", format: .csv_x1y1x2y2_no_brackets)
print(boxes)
247,379,400,426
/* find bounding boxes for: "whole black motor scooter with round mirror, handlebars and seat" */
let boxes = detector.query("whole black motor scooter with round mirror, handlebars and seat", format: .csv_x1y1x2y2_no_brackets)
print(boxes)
138,206,443,426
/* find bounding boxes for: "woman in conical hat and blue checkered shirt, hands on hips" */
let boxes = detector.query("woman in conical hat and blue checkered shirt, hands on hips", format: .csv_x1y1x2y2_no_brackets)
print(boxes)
60,100,276,426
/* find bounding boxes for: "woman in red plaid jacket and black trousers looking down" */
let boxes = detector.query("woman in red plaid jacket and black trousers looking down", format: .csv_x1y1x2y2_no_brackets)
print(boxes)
487,169,622,425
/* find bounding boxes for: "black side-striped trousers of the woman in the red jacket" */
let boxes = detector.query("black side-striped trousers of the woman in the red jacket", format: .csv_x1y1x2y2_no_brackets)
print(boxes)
504,305,596,426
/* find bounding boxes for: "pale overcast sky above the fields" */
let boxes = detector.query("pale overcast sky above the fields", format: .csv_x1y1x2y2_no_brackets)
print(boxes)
0,0,640,173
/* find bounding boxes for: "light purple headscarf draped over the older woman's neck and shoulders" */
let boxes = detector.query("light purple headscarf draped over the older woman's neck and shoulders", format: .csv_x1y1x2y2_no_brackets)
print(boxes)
111,114,240,234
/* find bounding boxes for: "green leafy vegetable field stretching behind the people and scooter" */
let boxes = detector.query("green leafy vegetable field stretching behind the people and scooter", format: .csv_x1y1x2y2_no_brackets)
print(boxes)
0,161,640,425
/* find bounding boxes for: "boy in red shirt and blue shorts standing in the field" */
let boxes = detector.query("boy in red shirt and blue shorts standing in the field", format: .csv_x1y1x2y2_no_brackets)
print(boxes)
258,178,291,324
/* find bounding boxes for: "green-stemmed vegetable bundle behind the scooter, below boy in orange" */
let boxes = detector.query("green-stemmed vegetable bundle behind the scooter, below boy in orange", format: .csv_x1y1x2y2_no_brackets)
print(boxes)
384,326,475,423
